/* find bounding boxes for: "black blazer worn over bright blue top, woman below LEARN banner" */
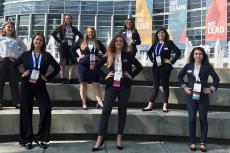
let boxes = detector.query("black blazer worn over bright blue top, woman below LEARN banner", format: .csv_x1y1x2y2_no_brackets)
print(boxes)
147,40,181,66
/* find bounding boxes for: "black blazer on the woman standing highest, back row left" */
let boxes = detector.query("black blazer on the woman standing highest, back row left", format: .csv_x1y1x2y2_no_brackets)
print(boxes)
52,25,83,47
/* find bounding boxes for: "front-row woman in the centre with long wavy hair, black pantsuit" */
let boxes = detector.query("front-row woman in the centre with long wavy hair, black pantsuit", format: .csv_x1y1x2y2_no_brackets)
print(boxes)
92,34,142,151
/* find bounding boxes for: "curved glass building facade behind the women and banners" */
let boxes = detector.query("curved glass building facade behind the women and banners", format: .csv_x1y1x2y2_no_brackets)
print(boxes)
0,0,230,49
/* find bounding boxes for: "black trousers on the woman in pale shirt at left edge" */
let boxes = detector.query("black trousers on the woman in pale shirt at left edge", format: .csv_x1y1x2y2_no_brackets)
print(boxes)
0,58,19,106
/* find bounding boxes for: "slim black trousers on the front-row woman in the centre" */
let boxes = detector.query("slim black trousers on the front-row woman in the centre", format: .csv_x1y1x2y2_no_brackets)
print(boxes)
98,87,131,136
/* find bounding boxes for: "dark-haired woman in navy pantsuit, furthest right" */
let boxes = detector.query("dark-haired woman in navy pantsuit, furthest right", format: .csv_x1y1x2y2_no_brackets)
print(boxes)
178,47,220,152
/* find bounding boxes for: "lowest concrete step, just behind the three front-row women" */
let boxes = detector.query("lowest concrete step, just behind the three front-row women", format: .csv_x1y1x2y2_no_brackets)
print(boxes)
0,108,230,139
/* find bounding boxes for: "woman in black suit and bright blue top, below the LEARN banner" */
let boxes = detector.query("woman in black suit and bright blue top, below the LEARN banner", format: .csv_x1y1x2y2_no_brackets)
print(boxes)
142,28,181,112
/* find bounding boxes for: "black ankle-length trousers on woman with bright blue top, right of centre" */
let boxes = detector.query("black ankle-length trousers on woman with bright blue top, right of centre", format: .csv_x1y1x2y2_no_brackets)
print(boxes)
149,64,172,103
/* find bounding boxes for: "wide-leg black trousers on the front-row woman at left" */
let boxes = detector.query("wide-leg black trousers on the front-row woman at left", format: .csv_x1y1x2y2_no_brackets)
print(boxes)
19,80,51,144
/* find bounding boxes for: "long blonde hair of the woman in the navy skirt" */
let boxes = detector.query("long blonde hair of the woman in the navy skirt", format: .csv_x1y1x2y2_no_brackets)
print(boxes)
80,27,99,51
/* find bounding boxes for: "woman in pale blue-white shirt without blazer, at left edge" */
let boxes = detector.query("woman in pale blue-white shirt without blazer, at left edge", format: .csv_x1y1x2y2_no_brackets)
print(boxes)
0,21,27,110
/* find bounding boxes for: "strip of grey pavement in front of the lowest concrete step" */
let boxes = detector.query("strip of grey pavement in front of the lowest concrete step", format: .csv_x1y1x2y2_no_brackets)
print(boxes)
0,140,230,153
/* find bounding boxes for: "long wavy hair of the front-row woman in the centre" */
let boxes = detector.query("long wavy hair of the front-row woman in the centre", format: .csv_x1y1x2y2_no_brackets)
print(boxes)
106,34,127,67
